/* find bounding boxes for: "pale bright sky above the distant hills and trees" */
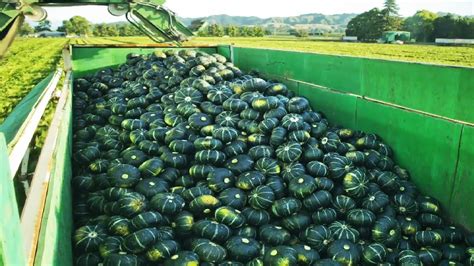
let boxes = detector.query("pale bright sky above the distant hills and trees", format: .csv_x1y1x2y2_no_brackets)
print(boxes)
41,0,474,26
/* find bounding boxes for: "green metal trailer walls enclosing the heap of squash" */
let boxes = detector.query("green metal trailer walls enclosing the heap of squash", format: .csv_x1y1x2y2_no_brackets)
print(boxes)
31,46,474,265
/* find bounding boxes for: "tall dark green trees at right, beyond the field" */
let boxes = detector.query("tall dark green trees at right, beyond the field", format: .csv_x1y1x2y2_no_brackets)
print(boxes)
346,0,474,42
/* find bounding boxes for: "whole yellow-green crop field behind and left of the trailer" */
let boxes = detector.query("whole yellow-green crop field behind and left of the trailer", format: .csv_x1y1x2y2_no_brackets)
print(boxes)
0,34,474,123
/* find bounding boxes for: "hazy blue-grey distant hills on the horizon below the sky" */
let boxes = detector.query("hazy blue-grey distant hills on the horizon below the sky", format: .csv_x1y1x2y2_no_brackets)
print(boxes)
180,13,357,32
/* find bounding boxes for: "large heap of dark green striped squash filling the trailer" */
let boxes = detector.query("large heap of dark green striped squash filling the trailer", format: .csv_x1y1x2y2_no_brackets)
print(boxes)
72,50,474,266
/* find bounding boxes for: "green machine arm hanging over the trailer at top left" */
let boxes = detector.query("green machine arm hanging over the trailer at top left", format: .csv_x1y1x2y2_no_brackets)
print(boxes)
0,0,203,57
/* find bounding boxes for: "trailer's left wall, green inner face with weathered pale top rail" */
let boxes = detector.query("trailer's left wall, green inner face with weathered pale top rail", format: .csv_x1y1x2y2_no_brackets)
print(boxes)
34,72,73,266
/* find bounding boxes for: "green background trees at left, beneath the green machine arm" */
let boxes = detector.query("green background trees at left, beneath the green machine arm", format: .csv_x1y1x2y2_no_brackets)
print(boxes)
20,16,144,37
